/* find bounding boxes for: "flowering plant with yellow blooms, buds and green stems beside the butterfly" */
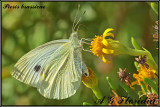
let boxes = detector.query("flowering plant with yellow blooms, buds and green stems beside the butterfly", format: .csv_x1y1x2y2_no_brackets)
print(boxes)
82,28,158,105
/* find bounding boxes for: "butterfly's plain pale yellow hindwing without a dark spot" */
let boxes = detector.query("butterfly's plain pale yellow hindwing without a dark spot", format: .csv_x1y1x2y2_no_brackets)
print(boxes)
38,44,82,99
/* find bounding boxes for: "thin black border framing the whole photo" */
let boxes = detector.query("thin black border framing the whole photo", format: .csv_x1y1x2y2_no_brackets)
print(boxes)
0,0,160,107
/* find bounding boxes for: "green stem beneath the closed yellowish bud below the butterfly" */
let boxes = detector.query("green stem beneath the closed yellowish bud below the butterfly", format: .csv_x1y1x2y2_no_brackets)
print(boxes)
91,86,108,105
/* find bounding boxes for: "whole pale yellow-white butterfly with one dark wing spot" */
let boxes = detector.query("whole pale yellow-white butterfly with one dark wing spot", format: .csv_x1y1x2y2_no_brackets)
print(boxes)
11,5,89,99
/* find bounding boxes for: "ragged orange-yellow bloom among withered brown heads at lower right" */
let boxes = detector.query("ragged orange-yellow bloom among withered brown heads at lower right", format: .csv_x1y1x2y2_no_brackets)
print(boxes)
132,66,156,85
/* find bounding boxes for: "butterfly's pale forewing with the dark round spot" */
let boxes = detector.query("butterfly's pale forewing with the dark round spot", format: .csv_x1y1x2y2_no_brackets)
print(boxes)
11,39,69,87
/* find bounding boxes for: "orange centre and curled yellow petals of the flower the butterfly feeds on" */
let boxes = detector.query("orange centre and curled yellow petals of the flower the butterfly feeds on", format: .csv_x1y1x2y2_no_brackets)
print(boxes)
90,28,114,63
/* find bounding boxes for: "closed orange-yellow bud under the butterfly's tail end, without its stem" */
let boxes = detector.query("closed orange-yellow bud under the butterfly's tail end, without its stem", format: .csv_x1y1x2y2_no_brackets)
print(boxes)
82,67,98,88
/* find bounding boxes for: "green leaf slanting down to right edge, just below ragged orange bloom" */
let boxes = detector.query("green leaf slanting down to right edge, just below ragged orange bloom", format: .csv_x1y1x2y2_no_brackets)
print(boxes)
143,78,158,95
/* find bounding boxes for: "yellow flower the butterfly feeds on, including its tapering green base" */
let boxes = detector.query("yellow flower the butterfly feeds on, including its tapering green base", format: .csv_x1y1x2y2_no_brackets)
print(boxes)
90,28,136,63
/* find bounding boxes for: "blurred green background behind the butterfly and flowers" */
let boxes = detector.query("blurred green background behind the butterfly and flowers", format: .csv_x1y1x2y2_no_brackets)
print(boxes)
2,2,158,105
